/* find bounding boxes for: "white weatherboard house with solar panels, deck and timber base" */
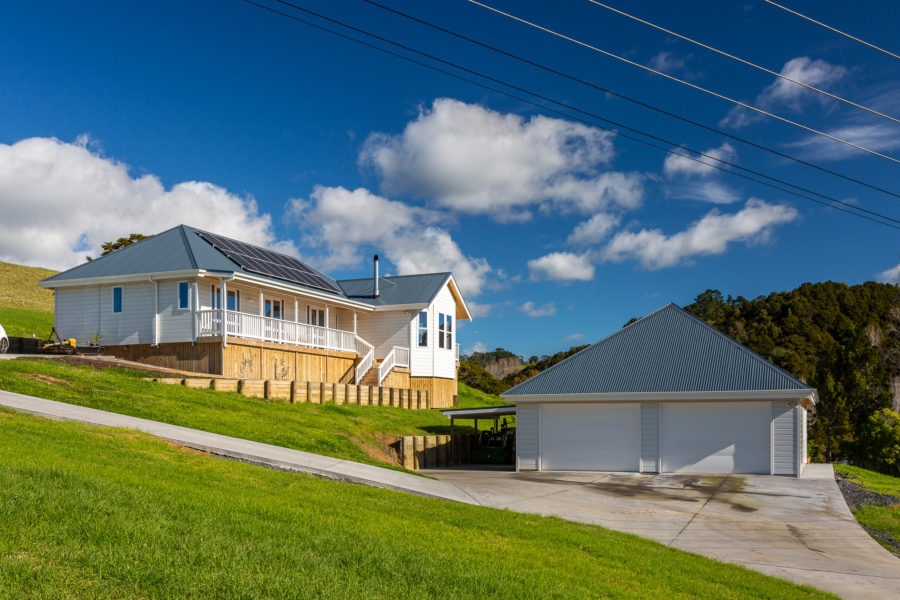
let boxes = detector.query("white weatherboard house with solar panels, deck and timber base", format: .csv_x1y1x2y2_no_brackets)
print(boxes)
40,225,471,407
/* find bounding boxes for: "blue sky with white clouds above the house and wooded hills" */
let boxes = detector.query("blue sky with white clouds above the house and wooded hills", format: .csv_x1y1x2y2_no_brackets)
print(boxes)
0,0,900,356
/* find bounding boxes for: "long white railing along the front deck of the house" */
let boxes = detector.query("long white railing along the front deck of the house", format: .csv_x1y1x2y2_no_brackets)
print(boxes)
197,310,358,356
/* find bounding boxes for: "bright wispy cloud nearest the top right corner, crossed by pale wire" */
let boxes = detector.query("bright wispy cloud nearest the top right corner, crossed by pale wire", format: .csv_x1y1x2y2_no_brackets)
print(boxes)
719,56,848,129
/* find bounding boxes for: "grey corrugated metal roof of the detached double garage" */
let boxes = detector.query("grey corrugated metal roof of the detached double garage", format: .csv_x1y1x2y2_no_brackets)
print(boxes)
502,304,814,397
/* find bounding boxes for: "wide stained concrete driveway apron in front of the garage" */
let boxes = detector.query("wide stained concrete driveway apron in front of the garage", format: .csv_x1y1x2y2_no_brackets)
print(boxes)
423,465,900,599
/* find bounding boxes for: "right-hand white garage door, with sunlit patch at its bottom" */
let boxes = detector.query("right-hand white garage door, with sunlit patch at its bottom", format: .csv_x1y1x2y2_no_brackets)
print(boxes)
659,402,772,473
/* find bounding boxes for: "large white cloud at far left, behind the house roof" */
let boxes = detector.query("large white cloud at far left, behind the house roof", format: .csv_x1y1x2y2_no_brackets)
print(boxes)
0,136,288,269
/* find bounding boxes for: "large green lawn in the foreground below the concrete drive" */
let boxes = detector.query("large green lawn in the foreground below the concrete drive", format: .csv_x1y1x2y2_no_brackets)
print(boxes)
0,410,833,600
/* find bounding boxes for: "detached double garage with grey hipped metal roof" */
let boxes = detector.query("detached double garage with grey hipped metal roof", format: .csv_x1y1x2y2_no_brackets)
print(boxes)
503,304,816,475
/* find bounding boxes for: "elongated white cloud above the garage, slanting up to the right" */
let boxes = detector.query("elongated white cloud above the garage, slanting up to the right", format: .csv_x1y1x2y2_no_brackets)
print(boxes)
601,198,798,269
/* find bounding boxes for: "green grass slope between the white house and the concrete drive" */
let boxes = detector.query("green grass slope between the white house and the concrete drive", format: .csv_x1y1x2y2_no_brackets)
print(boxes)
0,360,499,466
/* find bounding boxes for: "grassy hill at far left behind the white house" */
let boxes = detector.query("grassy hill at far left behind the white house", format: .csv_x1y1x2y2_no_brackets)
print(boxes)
0,262,56,338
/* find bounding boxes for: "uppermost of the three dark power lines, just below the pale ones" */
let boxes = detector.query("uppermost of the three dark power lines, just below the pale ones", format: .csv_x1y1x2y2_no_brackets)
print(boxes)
363,0,900,198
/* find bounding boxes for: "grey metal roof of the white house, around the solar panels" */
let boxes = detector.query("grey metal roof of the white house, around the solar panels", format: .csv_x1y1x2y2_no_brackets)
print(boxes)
43,225,450,306
